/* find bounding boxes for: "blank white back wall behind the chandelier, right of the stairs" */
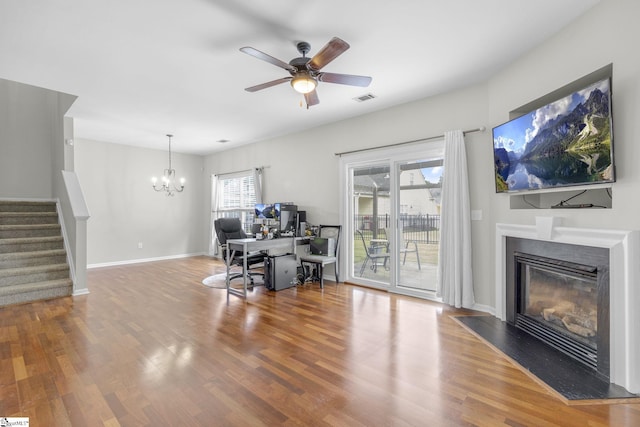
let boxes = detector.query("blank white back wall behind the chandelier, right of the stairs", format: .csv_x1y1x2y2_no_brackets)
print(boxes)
74,136,208,266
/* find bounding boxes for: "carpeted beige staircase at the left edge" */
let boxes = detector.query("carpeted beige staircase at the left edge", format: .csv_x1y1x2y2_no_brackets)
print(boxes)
0,200,73,307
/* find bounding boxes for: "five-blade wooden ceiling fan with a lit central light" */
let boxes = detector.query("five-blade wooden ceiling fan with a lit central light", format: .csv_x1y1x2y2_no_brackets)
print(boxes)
240,37,371,108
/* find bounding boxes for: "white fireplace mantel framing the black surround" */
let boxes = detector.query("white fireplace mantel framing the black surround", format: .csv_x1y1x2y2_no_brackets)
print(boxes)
495,221,640,393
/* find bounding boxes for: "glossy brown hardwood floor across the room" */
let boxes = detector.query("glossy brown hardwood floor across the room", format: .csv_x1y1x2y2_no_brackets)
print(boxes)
0,257,640,426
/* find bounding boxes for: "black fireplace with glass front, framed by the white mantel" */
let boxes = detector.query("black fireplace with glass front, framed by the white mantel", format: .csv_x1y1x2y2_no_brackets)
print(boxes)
506,237,609,380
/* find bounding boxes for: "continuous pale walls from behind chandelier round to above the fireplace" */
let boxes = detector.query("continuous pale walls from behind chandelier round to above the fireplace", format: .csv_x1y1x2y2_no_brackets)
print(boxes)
69,0,640,306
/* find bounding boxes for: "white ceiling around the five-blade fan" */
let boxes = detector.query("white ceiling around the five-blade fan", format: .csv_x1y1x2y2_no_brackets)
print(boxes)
0,0,599,154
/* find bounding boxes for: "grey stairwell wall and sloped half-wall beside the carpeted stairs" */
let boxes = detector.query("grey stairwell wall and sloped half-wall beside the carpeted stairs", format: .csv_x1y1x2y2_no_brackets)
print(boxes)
0,79,91,295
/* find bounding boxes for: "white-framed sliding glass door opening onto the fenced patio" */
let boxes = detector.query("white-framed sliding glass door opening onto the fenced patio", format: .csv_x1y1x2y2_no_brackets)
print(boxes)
341,141,443,298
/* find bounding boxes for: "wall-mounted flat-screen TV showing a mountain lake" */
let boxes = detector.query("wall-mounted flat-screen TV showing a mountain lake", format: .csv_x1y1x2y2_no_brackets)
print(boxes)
493,78,615,193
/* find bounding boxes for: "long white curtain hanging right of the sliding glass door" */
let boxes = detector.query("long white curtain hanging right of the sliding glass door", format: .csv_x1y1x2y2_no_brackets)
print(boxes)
437,130,475,308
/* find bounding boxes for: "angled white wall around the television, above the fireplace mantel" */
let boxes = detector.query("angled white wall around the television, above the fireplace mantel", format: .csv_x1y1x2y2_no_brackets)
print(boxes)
485,0,640,308
